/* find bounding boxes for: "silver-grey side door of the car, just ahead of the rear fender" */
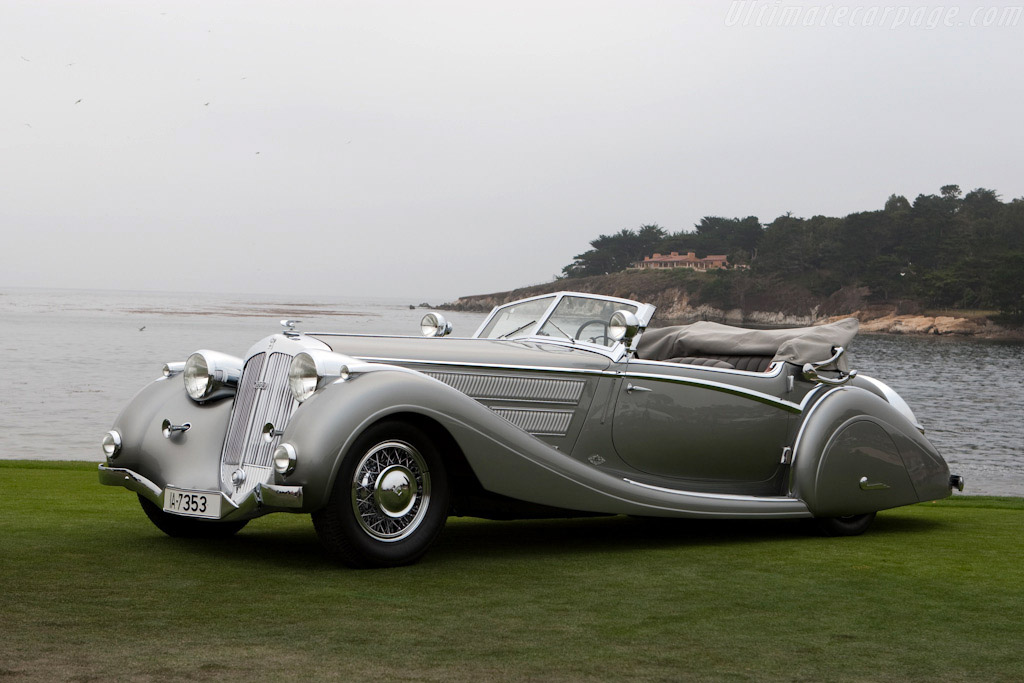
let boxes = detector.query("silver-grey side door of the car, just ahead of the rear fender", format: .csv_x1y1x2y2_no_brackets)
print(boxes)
612,359,799,493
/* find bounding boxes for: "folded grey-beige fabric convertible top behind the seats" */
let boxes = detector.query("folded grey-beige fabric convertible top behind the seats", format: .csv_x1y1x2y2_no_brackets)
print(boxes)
637,317,859,372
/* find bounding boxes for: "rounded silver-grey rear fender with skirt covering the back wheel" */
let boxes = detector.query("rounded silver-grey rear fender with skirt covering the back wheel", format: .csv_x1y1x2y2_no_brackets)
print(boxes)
791,386,949,517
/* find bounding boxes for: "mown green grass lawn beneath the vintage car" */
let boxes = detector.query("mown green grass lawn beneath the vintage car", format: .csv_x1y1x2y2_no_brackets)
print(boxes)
0,462,1024,681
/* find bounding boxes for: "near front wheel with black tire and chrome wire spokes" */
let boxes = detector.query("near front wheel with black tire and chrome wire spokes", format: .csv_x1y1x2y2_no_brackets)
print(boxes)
312,420,449,568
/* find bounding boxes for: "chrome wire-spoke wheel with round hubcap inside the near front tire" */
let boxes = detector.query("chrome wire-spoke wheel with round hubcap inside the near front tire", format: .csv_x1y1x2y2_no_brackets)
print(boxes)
352,441,430,543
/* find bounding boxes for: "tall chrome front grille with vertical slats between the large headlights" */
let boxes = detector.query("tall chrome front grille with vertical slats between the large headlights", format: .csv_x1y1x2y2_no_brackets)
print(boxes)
220,352,298,502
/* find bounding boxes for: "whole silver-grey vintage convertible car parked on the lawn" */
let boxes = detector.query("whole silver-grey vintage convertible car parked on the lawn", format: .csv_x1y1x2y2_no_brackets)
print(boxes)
99,292,964,566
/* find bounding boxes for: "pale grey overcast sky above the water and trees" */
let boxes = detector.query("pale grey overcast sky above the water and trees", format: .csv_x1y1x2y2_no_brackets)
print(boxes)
0,0,1024,302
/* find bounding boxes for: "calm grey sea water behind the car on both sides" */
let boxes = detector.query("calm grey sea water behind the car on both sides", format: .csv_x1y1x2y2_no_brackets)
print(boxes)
0,288,1024,497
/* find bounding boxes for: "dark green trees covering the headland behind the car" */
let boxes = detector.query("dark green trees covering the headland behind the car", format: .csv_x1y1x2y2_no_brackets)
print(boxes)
561,185,1024,317
